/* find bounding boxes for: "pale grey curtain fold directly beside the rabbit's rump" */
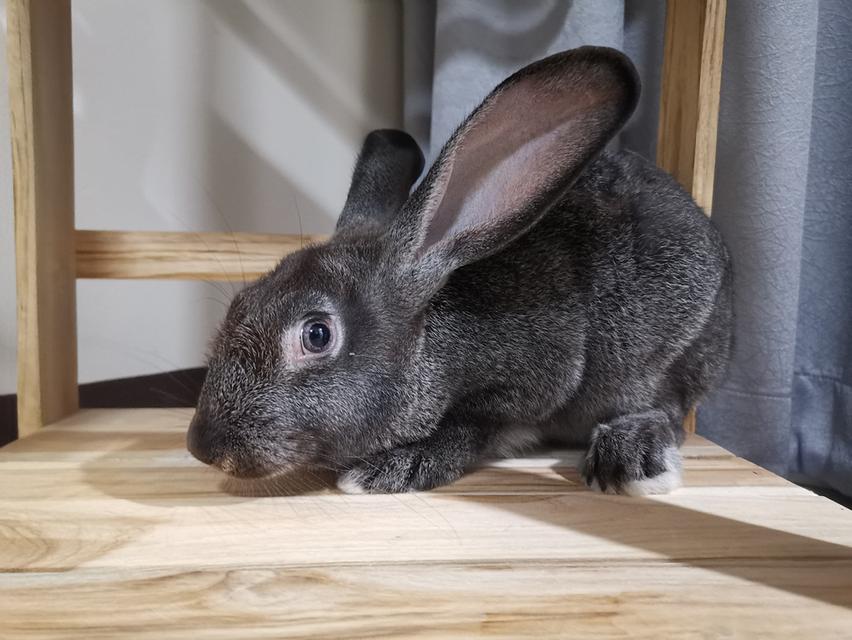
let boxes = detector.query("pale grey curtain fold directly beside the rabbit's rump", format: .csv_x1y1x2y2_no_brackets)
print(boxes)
699,1,818,473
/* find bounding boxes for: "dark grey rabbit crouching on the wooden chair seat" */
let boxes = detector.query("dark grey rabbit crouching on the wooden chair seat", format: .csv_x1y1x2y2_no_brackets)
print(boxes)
187,47,732,495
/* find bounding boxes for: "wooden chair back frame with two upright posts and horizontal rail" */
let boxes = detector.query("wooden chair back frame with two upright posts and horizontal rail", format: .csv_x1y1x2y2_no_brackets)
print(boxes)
6,0,726,437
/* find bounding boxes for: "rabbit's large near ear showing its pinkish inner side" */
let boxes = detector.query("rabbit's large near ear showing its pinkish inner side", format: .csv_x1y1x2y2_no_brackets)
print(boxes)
391,47,639,279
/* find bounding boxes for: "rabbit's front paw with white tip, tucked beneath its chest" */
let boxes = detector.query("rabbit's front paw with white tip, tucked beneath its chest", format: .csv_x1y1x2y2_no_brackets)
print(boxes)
337,444,461,493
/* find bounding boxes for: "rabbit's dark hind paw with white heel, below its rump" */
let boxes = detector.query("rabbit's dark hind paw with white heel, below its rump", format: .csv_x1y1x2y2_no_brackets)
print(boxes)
582,411,681,496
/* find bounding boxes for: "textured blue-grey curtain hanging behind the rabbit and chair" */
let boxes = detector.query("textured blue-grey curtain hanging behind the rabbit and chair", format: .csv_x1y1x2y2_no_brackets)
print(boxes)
404,0,852,494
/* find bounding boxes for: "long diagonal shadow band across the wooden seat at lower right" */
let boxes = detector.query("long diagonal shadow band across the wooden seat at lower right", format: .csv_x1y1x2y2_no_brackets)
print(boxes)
448,469,852,609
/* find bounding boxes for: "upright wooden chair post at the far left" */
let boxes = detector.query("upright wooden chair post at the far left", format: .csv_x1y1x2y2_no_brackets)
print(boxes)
6,0,77,435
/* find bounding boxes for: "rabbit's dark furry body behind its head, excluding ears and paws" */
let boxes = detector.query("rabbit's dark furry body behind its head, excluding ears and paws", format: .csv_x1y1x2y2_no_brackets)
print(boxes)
428,147,731,425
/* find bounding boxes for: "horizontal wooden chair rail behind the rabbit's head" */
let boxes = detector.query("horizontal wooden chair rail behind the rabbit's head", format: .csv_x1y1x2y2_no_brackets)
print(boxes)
75,230,327,281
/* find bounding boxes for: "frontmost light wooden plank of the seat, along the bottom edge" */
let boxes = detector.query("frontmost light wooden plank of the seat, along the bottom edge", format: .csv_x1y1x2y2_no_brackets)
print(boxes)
5,559,852,640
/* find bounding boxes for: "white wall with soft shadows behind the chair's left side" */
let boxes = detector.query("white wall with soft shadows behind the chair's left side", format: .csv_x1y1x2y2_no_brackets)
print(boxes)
0,0,402,393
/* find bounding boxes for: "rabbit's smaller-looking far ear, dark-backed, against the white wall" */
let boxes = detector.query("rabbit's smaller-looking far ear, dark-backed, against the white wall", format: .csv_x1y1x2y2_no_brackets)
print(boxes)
335,129,423,234
